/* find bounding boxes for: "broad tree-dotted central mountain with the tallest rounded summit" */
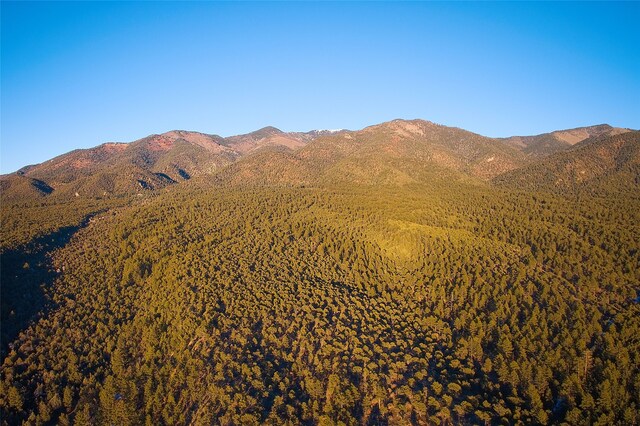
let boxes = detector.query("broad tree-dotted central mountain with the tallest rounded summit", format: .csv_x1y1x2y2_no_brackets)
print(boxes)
216,120,523,185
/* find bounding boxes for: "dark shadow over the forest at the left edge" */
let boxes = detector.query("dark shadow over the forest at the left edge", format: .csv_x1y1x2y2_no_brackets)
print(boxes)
0,213,95,362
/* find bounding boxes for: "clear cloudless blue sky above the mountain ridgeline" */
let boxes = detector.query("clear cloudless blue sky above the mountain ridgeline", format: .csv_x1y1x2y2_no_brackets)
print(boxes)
0,1,640,173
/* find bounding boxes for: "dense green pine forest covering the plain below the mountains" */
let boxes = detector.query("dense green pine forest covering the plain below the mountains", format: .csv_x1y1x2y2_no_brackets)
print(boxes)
0,121,640,425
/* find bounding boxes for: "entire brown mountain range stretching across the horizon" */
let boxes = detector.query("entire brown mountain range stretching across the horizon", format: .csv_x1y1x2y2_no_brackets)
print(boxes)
0,120,640,201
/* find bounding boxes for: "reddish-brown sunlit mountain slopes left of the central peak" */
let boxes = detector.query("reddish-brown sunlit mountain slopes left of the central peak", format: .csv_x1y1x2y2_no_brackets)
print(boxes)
0,128,320,202
